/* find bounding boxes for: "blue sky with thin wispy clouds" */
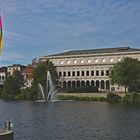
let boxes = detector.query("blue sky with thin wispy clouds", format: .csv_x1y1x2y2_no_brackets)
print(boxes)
0,0,140,67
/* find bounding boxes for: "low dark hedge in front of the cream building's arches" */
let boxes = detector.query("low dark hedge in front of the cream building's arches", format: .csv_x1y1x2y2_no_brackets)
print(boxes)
66,86,98,93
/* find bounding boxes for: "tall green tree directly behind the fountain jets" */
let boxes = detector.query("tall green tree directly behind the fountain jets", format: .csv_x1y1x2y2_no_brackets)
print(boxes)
32,60,59,94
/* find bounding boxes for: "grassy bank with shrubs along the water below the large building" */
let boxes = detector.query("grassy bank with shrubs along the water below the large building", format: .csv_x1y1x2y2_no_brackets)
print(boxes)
58,93,140,103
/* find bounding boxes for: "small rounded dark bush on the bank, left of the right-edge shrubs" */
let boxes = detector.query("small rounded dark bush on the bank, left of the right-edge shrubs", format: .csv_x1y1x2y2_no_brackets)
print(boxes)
106,92,121,102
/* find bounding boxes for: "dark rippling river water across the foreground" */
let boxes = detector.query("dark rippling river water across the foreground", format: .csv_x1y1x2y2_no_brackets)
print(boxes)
0,100,140,140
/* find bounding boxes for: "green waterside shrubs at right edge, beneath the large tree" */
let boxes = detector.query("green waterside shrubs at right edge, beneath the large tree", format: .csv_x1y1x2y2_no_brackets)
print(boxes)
123,93,140,103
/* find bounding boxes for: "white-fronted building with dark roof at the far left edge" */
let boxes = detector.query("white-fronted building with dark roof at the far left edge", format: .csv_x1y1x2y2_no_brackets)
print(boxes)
0,67,7,85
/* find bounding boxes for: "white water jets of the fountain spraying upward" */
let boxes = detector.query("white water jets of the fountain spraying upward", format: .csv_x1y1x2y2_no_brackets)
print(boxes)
38,71,57,101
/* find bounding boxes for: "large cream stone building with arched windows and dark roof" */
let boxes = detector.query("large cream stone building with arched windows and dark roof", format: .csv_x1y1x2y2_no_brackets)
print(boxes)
40,47,140,91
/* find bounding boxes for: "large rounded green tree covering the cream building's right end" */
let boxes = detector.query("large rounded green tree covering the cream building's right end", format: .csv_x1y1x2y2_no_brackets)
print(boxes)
110,57,140,92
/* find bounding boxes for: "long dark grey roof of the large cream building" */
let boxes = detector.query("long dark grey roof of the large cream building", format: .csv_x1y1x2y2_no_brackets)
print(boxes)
44,47,140,57
